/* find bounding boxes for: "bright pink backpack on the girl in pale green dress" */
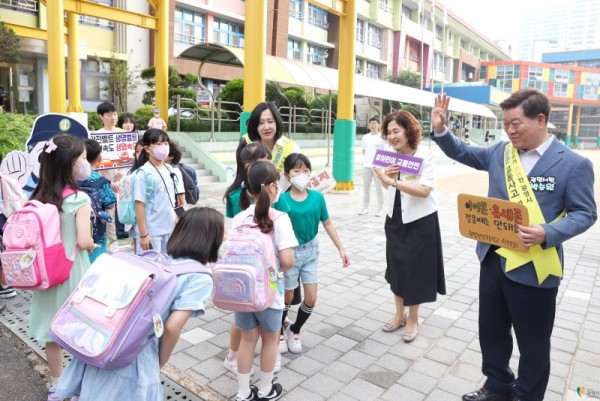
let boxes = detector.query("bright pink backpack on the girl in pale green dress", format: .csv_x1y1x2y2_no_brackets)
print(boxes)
0,188,75,290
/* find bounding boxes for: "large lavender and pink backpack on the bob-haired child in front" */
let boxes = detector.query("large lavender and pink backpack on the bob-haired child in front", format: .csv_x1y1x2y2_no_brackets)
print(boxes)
50,251,210,369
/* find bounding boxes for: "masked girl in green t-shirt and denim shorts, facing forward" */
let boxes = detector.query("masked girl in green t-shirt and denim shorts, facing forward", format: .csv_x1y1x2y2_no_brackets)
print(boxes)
275,153,350,354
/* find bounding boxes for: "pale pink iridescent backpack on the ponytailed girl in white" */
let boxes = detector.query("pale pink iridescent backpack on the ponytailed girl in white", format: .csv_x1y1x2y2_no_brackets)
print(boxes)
213,213,283,312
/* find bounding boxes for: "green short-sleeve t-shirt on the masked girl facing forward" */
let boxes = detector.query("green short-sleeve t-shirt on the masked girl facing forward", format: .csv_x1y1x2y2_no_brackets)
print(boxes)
276,189,329,245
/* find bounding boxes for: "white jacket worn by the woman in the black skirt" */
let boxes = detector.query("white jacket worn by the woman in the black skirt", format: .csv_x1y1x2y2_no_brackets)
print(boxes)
387,147,438,224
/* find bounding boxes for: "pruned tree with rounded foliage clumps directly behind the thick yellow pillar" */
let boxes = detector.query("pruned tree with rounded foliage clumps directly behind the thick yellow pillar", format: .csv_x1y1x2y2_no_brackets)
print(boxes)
140,65,198,108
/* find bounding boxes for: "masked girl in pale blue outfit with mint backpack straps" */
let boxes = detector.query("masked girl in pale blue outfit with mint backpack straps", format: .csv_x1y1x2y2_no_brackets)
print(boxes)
133,129,184,255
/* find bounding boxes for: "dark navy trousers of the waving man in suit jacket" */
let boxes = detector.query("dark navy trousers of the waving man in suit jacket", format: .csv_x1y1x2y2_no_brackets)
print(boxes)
479,248,558,401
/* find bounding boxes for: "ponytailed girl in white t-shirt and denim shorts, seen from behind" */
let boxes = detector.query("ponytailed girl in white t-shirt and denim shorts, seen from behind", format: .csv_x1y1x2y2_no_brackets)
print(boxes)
230,161,298,401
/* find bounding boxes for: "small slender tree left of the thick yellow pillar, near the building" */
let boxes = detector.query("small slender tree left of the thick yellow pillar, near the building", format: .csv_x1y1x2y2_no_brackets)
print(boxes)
98,49,142,111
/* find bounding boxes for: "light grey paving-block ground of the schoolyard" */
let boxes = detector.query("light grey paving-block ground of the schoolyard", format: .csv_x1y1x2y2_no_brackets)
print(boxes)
0,147,600,401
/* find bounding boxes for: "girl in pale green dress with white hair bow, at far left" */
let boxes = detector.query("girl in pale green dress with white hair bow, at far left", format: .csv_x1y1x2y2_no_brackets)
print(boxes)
29,134,94,401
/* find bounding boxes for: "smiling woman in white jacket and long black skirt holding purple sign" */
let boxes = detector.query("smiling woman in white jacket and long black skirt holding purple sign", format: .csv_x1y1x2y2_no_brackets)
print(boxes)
373,110,446,342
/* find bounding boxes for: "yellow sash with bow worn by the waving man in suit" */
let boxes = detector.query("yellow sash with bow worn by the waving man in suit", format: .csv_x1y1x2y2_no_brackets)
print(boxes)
496,143,565,284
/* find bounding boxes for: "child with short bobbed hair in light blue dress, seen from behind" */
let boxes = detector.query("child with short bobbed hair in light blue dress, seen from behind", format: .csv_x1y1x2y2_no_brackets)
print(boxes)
56,207,225,401
